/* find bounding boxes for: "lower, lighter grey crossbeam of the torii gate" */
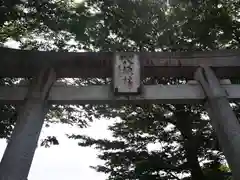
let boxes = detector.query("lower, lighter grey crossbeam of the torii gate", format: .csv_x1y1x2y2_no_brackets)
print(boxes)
0,84,240,104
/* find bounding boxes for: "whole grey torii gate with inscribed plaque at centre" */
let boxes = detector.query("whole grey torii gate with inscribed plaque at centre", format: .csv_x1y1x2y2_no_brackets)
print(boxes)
0,48,240,180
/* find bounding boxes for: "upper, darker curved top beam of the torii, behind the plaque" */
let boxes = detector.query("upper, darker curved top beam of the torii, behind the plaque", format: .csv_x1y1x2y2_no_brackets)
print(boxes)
0,47,240,78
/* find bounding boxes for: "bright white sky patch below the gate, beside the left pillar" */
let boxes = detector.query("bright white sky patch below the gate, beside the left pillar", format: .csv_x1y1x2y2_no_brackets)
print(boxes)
0,119,114,180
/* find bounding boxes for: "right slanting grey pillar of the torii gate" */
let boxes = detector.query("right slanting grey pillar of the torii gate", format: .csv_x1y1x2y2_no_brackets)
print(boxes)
195,67,240,180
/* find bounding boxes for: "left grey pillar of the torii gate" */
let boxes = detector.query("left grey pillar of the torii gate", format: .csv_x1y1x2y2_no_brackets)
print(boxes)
0,68,56,180
